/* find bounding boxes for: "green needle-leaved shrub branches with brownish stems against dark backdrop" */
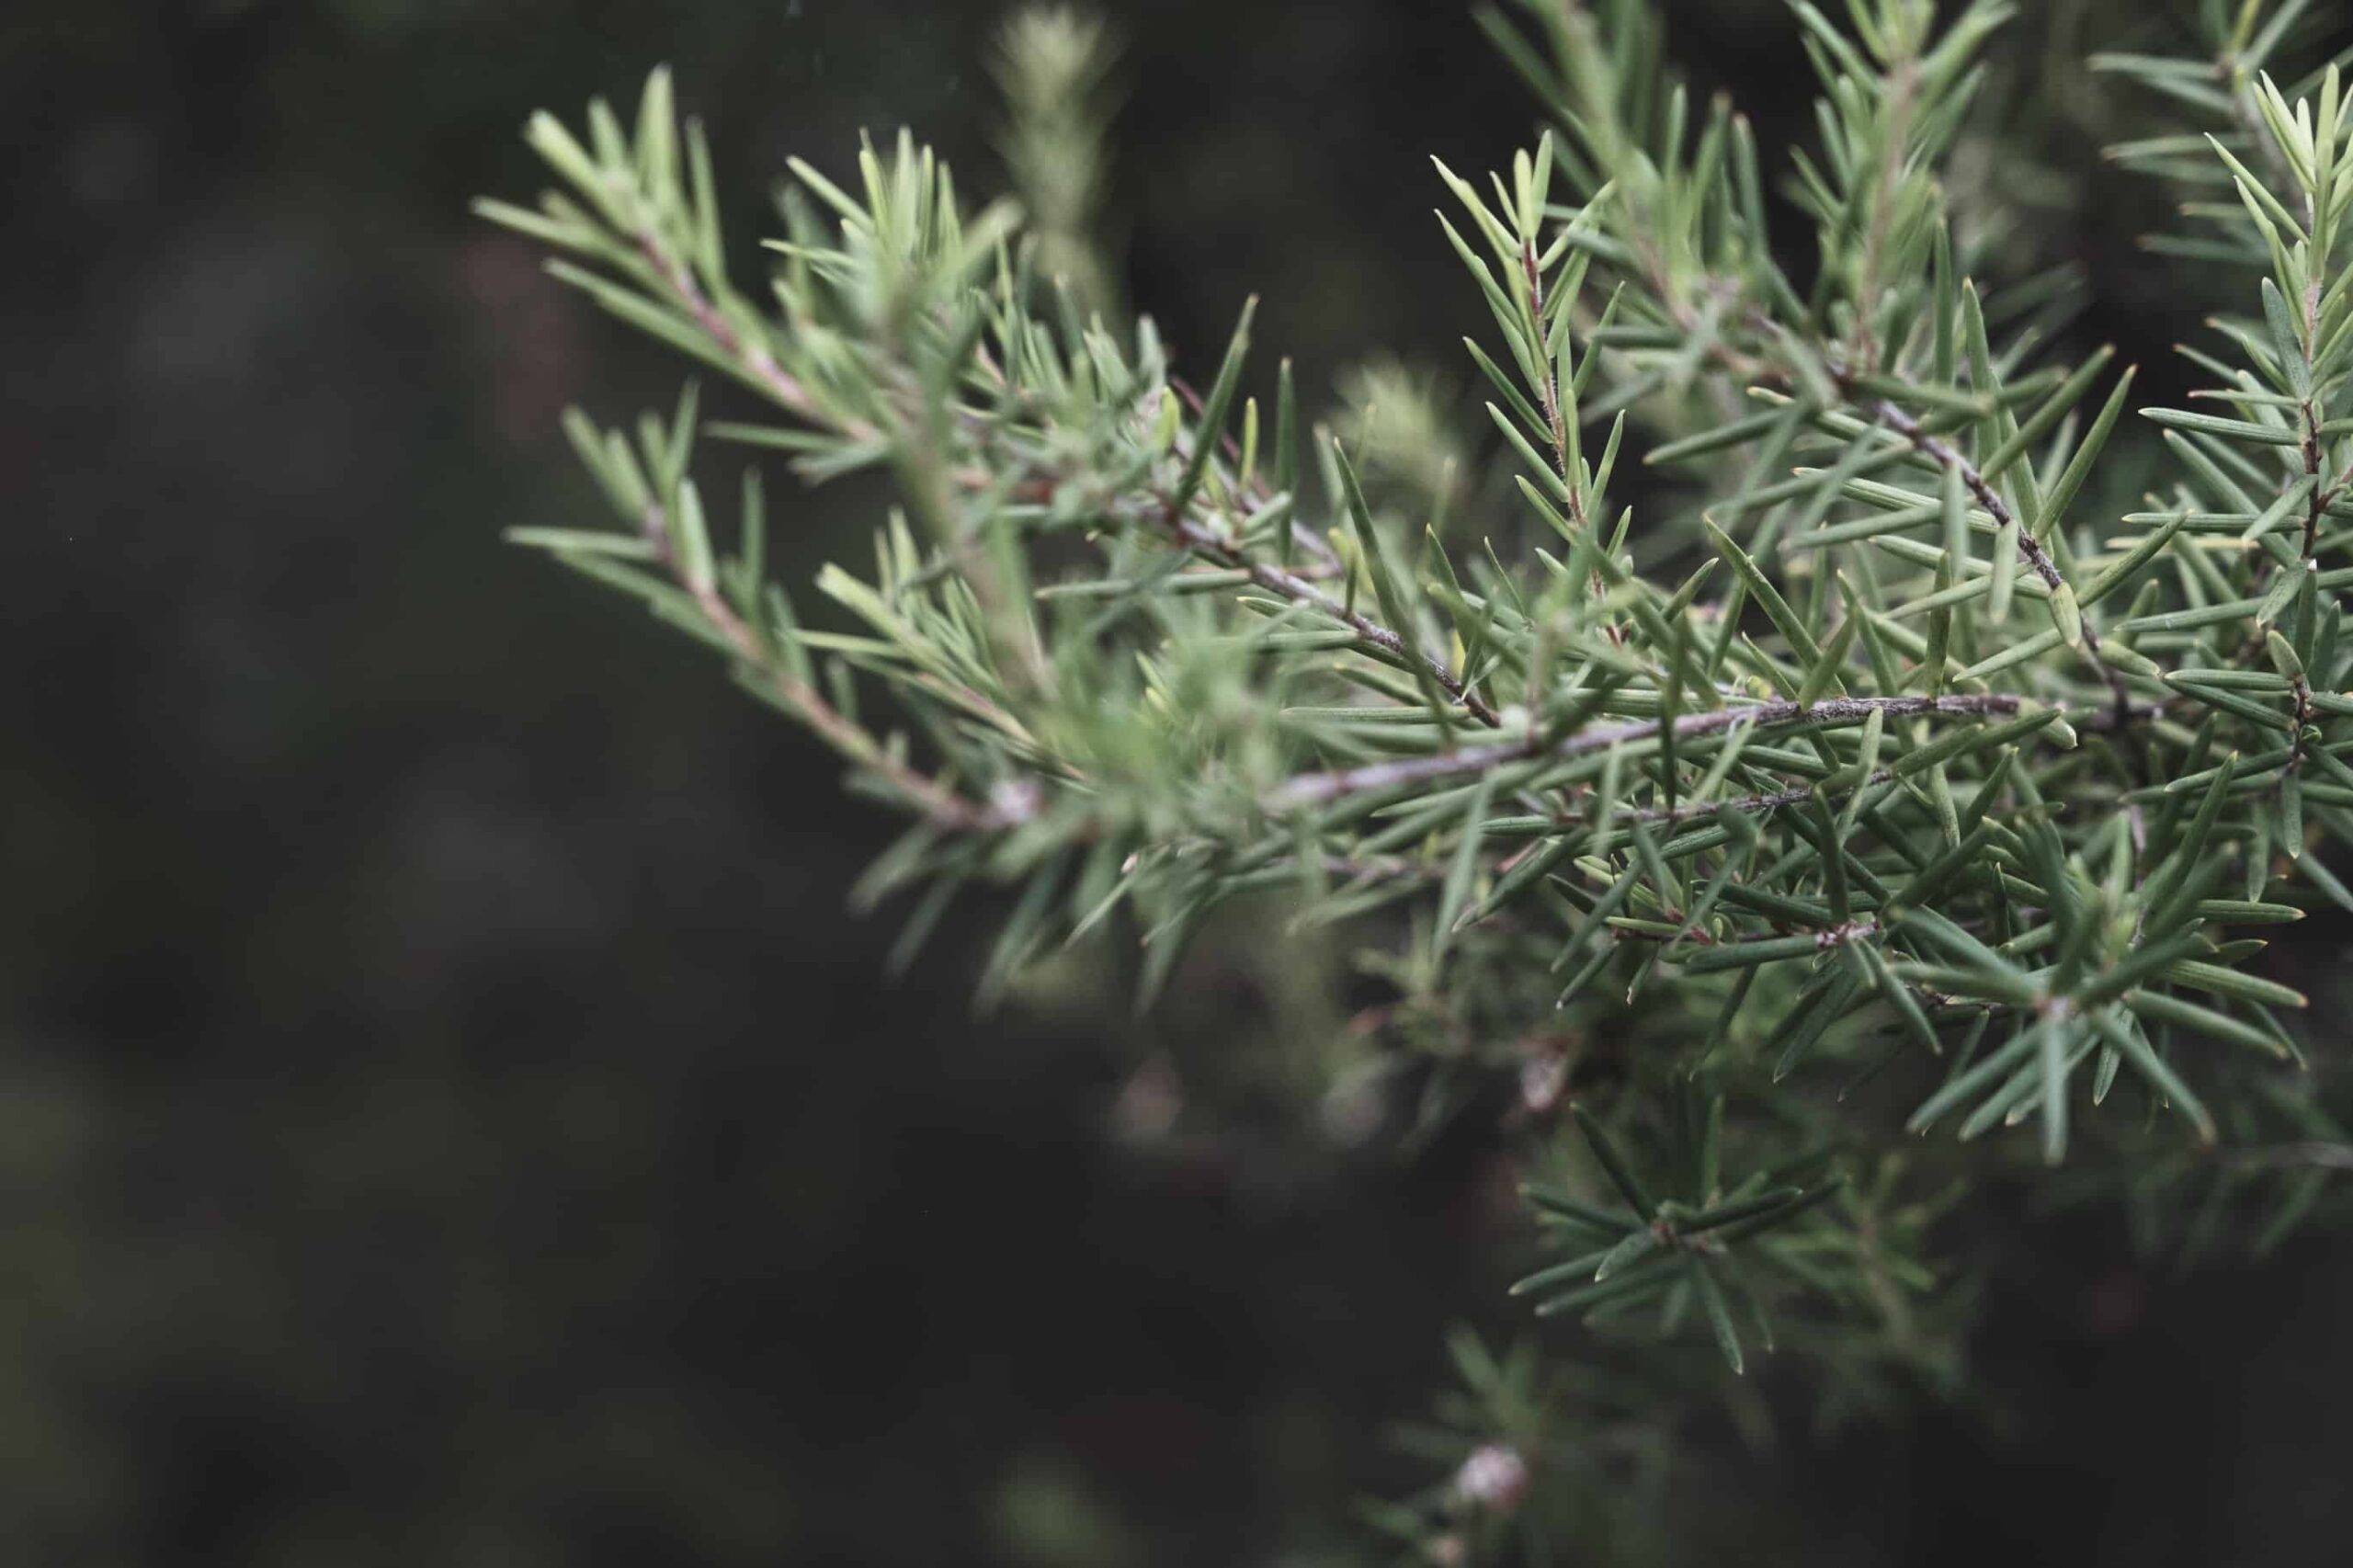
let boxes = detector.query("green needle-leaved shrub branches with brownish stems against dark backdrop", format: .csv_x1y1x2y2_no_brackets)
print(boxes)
483,0,2353,1544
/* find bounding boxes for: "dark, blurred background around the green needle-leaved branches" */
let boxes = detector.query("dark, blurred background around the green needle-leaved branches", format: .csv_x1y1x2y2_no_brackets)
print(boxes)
0,0,2353,1568
